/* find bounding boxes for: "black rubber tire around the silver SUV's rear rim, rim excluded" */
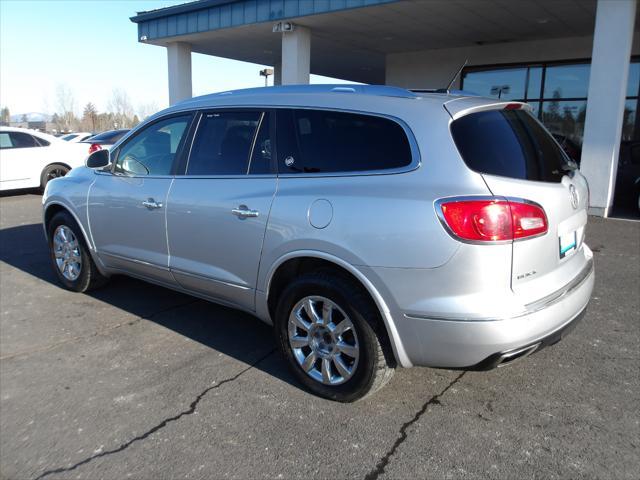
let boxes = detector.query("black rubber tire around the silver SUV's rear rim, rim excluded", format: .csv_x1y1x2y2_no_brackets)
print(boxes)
274,275,378,402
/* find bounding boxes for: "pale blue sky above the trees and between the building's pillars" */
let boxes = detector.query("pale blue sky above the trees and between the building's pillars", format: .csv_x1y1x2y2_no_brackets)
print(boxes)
0,0,348,115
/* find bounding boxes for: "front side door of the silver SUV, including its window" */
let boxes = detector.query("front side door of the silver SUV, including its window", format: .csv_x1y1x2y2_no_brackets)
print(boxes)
88,114,192,285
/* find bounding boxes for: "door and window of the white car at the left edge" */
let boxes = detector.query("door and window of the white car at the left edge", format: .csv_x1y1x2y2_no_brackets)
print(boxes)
0,131,47,190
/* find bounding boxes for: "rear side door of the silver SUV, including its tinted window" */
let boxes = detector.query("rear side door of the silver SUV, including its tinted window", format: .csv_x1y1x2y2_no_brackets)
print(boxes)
167,110,277,310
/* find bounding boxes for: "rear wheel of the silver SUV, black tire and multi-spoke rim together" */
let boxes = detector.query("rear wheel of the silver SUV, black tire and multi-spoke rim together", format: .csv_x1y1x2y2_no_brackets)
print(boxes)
274,271,395,402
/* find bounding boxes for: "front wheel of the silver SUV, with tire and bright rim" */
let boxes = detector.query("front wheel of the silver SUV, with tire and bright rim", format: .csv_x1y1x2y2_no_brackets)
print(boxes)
47,212,108,292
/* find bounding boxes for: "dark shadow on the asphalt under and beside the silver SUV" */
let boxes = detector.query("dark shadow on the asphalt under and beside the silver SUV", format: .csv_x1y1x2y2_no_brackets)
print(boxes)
0,224,300,388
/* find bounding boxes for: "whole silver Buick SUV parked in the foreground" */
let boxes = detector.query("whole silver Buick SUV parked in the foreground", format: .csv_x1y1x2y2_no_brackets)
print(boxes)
43,85,594,402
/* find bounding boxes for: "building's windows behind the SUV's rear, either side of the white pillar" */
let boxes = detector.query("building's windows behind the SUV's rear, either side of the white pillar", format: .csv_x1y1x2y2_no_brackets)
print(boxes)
461,58,640,154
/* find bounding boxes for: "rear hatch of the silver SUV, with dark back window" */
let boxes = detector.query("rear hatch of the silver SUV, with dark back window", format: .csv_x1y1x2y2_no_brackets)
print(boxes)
450,103,590,303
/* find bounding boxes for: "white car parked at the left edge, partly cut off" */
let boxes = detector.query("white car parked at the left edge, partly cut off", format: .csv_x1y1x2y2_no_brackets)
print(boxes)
0,127,87,190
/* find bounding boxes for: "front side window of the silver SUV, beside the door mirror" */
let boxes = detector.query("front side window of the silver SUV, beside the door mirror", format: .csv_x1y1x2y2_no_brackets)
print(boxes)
114,115,191,175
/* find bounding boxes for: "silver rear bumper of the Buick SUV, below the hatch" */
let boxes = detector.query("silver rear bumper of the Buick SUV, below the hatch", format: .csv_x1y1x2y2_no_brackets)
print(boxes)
395,259,595,370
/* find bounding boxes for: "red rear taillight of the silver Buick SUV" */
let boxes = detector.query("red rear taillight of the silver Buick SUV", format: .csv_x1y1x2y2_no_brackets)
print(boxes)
436,197,549,242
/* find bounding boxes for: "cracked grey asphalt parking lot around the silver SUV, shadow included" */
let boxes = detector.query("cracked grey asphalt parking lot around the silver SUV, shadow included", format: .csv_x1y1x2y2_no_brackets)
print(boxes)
0,193,640,479
